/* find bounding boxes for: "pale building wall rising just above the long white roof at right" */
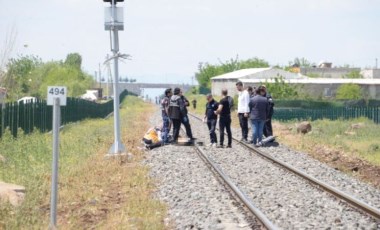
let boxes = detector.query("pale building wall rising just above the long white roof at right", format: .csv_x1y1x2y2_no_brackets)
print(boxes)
300,68,360,78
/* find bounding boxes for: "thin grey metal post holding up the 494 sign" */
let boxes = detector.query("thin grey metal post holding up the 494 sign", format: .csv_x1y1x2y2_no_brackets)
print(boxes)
49,98,61,229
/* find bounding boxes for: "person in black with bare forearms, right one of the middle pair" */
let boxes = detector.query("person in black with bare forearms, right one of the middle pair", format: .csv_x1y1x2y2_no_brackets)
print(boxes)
215,89,232,148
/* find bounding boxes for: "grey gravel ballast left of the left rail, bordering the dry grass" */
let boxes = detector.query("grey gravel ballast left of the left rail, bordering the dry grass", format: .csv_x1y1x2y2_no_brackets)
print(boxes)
144,114,260,230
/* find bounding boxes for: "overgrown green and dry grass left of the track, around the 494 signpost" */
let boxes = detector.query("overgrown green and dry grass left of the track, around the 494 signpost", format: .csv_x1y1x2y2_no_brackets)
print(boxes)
0,96,166,229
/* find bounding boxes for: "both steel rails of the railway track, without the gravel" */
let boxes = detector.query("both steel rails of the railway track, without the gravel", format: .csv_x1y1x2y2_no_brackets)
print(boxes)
189,114,380,229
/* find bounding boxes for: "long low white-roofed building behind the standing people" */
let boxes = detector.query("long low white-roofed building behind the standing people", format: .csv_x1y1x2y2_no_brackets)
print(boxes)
211,68,380,99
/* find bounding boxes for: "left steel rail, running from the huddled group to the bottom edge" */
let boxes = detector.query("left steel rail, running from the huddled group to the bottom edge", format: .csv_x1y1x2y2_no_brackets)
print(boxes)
177,127,278,230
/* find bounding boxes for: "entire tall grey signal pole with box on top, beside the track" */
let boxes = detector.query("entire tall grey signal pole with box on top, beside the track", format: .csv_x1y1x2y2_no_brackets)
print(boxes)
103,0,126,155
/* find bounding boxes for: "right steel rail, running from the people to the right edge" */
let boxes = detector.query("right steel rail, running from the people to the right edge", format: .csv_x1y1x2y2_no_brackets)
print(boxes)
189,113,380,219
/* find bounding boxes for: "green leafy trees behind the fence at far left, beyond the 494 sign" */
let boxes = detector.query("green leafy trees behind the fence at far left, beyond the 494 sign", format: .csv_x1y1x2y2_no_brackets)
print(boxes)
0,53,94,101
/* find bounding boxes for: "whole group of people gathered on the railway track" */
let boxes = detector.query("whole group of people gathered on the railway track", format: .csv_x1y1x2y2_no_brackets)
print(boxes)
146,81,274,148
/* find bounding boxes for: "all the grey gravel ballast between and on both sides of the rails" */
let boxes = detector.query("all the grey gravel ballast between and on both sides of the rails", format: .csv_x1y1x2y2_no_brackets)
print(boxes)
145,110,380,229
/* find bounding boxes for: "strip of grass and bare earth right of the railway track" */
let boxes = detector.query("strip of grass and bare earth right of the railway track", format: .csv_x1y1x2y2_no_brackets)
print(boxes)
273,119,380,187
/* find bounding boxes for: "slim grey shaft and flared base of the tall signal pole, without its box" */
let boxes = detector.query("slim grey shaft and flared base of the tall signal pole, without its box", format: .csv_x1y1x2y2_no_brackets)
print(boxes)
109,0,125,154
